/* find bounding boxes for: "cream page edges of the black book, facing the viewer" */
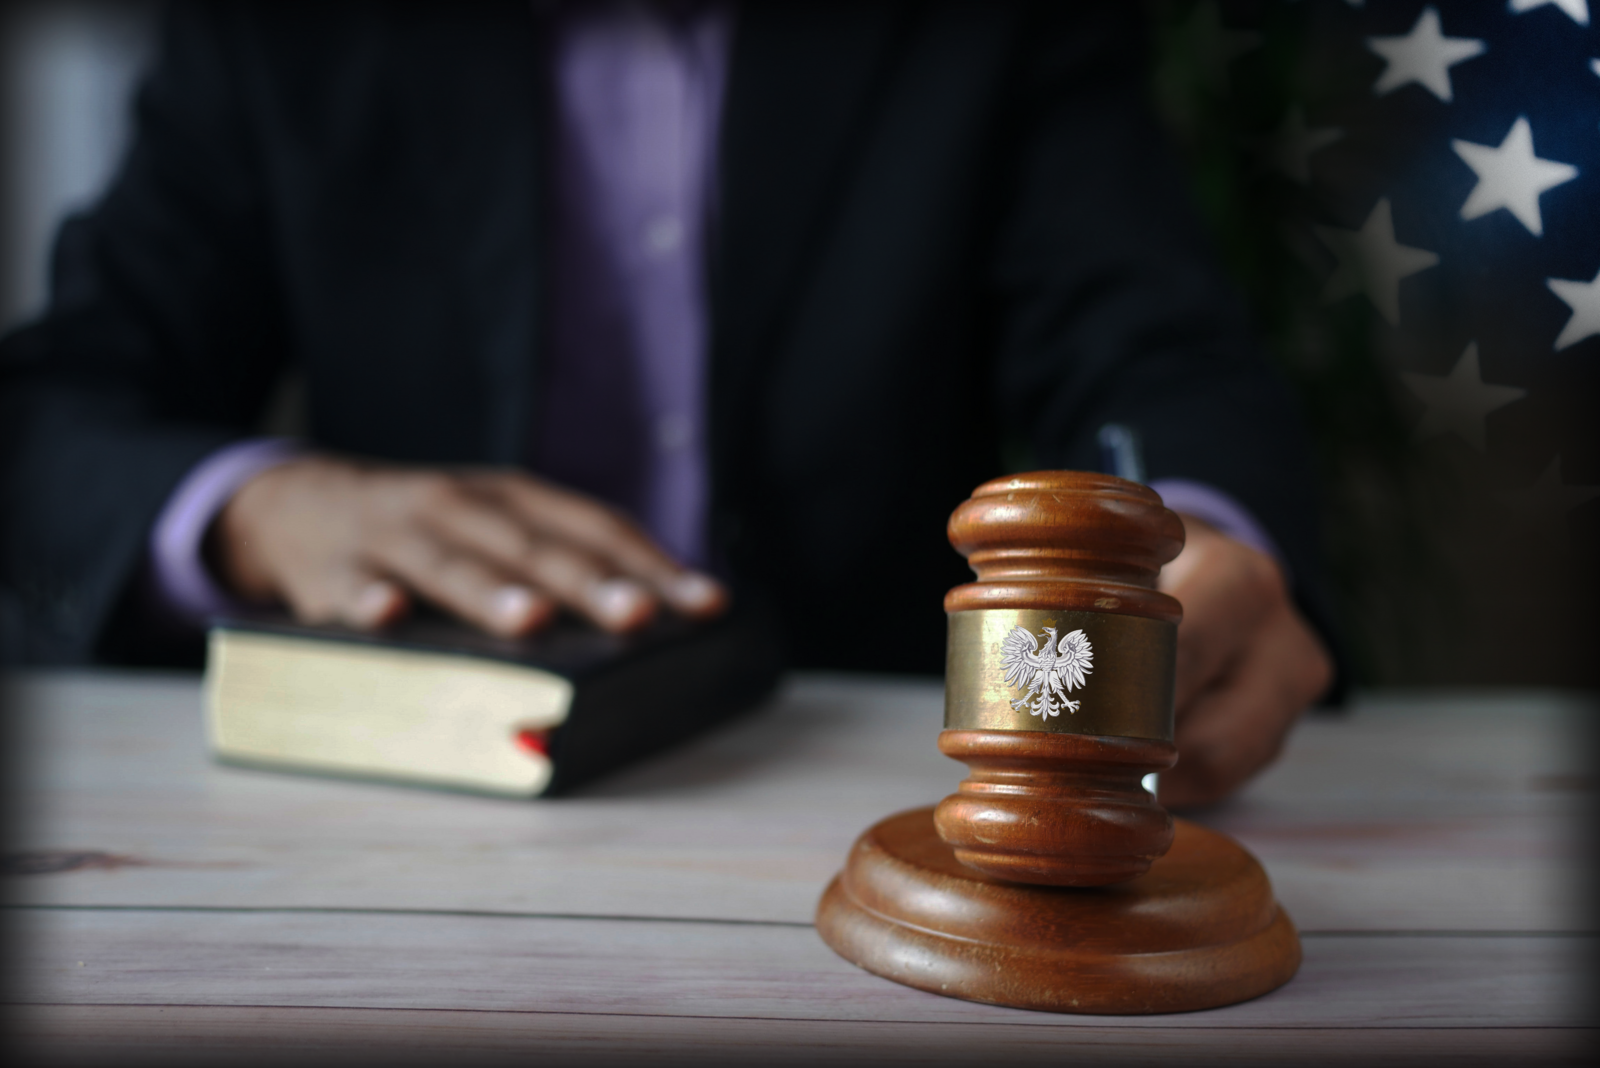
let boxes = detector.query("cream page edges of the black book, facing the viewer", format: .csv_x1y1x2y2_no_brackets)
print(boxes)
205,628,573,798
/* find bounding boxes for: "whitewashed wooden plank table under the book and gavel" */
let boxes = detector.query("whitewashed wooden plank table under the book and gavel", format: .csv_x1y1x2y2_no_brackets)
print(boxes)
3,673,1597,1065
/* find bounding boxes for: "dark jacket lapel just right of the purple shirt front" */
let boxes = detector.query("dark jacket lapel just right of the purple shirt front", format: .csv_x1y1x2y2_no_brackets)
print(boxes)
710,3,904,483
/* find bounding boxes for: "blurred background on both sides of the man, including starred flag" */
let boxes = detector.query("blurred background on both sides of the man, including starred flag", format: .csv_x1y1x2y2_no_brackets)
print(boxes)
0,0,1600,686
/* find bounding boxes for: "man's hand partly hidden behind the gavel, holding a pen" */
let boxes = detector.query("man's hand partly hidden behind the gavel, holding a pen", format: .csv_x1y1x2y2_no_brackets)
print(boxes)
1160,515,1333,807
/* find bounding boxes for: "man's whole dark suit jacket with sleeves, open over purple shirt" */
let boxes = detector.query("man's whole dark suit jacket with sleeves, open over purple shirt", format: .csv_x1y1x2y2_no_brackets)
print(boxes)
0,0,1325,671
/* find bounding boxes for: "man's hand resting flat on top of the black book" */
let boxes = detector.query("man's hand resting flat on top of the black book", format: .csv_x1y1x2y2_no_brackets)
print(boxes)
208,456,726,636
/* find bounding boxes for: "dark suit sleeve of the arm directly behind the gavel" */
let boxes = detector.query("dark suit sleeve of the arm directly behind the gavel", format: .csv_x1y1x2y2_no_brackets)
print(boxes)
992,5,1338,693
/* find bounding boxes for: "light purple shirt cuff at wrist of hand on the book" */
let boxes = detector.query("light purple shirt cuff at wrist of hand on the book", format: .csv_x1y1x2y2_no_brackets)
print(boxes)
149,438,301,625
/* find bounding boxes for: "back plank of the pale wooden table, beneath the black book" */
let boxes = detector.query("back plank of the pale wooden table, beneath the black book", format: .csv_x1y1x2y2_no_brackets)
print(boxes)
5,673,1595,931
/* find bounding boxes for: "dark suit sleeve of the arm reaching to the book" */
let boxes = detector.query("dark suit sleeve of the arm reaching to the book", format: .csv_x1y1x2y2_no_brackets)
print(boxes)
0,5,283,664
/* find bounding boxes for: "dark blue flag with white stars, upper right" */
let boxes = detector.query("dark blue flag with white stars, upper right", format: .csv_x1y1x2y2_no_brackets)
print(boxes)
1277,0,1600,526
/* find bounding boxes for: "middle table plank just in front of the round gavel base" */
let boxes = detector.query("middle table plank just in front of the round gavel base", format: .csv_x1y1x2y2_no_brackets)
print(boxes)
5,910,1594,1028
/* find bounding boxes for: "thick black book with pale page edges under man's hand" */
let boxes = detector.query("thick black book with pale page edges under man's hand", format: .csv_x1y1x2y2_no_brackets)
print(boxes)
205,614,778,798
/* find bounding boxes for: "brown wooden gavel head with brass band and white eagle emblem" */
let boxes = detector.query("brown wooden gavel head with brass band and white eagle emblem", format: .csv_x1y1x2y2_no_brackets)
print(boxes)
934,472,1184,886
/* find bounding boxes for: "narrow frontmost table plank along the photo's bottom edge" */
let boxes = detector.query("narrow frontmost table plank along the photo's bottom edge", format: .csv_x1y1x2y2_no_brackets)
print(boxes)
13,1006,1600,1068
